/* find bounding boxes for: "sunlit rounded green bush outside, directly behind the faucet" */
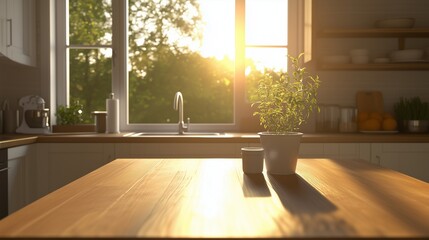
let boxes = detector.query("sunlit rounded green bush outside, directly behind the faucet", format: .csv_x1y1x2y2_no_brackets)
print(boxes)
129,53,234,123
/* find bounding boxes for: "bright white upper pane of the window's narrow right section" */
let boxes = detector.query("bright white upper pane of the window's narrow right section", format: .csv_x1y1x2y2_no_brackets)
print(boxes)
246,0,288,46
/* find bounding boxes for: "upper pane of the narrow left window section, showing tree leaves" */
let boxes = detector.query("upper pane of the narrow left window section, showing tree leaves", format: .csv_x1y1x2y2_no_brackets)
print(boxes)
69,0,112,45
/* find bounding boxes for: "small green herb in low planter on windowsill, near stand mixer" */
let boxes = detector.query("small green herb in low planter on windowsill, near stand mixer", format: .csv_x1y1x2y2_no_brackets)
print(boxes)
52,101,95,133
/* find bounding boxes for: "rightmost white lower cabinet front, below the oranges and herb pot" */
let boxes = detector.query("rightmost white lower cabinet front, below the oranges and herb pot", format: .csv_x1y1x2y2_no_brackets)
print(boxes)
371,143,429,182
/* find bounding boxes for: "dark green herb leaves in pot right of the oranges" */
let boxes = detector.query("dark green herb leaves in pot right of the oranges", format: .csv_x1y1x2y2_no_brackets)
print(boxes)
393,97,429,121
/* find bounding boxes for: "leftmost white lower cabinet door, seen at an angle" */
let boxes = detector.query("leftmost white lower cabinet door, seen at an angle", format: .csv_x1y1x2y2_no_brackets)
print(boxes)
8,144,36,213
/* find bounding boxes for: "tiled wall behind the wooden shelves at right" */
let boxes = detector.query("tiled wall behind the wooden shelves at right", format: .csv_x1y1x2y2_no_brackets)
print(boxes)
298,0,429,131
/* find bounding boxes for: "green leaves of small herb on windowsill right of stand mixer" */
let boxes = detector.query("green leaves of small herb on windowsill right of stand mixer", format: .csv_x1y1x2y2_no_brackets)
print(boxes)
55,101,83,125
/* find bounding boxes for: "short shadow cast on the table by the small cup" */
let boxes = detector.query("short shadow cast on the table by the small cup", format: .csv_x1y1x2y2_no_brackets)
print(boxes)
242,173,271,197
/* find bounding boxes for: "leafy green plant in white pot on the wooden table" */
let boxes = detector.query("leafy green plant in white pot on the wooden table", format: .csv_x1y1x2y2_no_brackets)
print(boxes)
252,54,320,174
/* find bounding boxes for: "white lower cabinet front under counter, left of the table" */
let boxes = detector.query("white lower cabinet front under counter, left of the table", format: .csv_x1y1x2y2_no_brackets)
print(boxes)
37,143,115,196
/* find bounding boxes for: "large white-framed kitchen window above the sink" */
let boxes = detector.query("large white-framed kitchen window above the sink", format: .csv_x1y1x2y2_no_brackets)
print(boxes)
57,0,298,131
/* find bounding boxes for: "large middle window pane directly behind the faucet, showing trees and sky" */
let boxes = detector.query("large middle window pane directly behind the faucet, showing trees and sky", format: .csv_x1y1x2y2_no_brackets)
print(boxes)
129,0,235,123
